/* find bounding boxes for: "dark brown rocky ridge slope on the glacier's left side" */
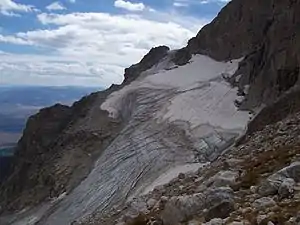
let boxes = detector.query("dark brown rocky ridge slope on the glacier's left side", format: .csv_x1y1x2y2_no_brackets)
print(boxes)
0,91,119,210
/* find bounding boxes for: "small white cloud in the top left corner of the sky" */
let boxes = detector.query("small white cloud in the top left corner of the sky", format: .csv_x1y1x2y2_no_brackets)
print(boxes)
0,0,36,16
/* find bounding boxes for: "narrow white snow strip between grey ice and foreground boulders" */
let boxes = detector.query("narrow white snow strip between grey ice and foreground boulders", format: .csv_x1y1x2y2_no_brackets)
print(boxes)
142,163,207,195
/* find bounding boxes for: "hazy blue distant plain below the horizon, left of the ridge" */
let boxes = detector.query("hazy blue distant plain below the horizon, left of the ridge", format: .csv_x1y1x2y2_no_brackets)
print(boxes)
0,86,103,148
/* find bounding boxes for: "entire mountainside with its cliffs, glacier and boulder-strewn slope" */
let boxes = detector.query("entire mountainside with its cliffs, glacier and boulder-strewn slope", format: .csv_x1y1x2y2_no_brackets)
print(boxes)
0,0,300,225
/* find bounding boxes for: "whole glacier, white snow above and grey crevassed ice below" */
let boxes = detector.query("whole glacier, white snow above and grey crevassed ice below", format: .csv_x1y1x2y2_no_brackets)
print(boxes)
1,55,249,225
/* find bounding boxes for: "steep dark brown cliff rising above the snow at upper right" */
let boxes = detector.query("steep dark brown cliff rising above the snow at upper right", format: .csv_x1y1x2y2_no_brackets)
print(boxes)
185,0,300,108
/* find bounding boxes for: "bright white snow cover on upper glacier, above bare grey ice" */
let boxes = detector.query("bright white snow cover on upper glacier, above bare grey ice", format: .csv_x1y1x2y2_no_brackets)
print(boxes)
101,55,248,129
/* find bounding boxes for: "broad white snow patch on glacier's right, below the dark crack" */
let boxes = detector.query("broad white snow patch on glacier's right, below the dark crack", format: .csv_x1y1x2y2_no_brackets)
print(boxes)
160,82,249,130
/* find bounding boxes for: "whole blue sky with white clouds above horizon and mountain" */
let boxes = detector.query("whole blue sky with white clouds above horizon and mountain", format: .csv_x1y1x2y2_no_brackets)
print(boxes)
0,0,229,87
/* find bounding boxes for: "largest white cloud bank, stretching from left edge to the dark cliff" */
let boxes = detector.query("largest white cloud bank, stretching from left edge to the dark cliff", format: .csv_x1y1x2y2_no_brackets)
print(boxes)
0,12,208,86
